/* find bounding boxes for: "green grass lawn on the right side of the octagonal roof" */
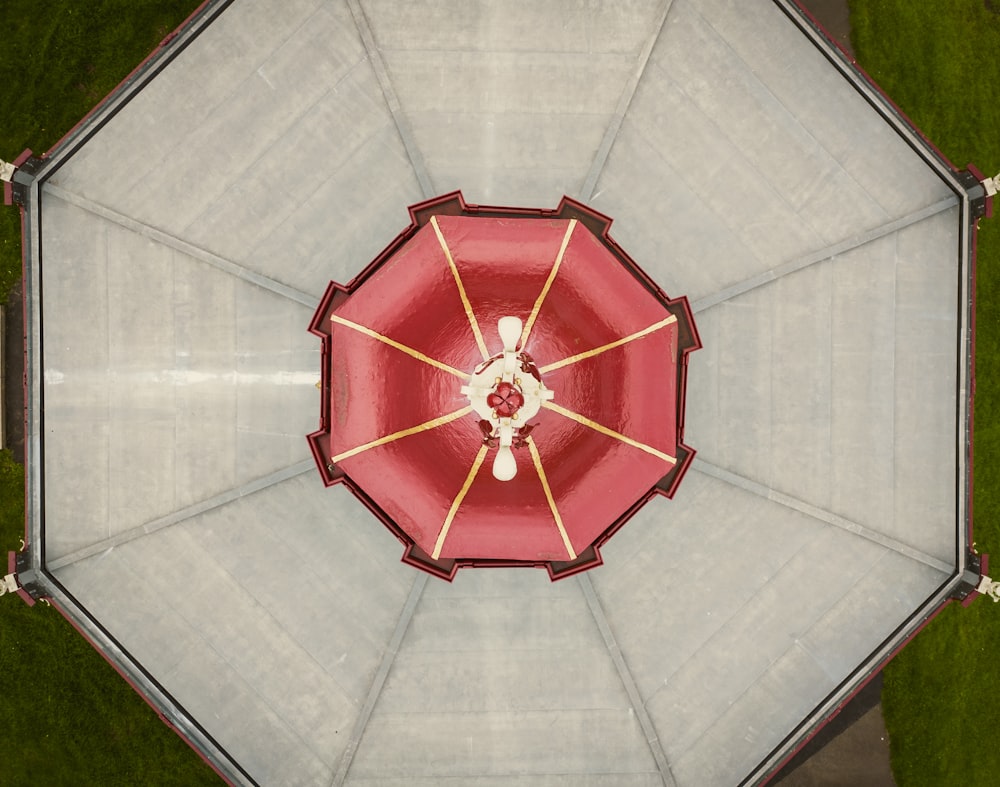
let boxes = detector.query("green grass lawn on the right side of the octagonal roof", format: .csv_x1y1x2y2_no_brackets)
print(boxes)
850,0,1000,787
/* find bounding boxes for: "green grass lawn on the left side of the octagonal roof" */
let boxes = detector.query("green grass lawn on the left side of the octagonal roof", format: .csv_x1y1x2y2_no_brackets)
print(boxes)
0,0,221,787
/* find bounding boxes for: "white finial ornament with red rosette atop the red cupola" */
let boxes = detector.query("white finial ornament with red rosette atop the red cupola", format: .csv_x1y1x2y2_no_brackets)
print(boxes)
462,317,554,481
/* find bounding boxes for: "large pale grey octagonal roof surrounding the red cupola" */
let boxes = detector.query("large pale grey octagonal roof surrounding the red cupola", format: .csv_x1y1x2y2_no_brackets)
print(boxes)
11,0,975,787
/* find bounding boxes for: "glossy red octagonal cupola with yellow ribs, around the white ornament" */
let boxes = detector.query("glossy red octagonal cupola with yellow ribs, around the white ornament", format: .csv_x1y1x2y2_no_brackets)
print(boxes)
309,194,700,579
